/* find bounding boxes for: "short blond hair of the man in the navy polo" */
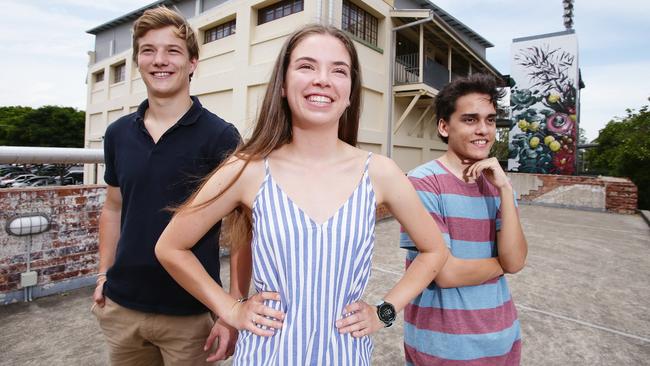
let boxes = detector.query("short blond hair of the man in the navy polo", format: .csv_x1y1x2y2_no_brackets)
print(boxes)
133,6,199,64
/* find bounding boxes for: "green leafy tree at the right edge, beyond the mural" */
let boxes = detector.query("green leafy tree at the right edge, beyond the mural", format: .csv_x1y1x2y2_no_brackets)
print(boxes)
587,98,650,209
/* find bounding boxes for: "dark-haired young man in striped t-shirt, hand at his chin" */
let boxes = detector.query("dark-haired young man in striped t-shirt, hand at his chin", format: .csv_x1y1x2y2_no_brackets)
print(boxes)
400,74,527,365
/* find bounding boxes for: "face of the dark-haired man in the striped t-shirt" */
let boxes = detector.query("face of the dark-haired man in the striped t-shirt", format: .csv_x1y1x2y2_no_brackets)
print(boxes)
438,93,496,161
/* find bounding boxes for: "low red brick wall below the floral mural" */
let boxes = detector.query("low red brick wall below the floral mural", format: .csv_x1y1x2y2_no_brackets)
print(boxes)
521,174,638,214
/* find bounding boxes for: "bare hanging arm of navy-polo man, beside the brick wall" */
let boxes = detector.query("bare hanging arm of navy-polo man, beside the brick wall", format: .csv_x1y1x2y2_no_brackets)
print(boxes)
93,185,122,307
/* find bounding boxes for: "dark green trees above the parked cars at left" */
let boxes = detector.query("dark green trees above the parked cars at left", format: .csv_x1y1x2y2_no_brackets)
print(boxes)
0,106,85,147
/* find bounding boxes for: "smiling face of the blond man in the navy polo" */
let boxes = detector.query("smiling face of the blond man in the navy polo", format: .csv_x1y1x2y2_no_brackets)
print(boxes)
137,26,197,98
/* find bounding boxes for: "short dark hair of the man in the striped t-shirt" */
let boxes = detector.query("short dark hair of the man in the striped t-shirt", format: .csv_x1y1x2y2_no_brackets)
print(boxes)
436,73,505,144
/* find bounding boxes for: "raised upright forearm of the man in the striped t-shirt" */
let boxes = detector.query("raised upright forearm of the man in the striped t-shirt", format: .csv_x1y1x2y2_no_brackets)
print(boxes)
497,187,528,273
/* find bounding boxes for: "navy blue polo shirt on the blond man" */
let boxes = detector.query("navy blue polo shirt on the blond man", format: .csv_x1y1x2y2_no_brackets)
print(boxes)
104,97,240,315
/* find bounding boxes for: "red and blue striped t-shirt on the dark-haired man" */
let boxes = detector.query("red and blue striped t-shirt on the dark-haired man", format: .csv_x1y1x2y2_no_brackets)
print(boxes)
400,160,521,366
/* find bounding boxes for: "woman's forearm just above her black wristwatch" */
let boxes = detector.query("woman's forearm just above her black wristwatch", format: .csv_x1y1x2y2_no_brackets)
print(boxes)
384,247,449,312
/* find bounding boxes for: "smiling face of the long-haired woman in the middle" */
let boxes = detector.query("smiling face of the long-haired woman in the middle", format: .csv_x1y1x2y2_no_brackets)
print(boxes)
282,34,352,127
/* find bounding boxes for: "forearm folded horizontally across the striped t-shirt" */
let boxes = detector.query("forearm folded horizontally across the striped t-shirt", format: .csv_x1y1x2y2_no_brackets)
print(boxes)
435,255,503,288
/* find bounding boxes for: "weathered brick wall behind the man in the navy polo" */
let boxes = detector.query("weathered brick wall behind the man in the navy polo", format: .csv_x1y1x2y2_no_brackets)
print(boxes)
0,185,105,294
